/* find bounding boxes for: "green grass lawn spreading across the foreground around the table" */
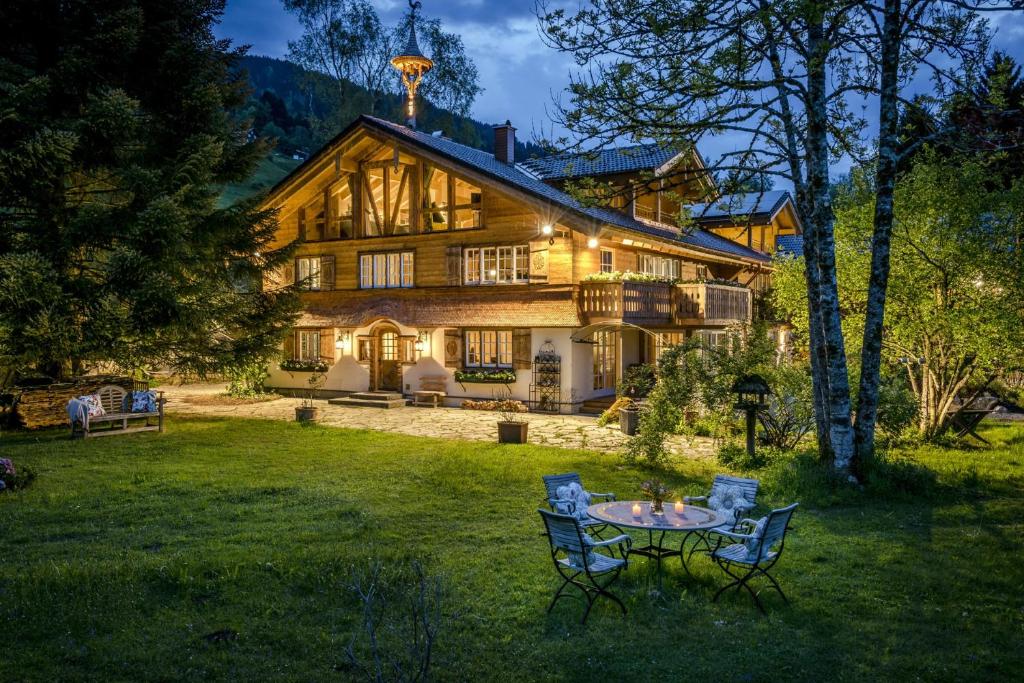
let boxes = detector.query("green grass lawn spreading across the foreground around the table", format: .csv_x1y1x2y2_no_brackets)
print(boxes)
0,418,1024,681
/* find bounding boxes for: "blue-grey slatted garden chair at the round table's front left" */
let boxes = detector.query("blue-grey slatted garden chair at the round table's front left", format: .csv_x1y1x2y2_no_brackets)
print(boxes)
538,510,633,624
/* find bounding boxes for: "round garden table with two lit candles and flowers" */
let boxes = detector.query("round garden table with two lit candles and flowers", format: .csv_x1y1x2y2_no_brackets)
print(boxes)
587,501,723,589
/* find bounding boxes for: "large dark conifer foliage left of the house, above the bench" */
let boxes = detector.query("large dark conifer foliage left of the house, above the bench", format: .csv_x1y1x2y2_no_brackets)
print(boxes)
0,0,297,379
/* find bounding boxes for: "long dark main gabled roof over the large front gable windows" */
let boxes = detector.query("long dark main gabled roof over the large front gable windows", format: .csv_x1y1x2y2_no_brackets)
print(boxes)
268,115,770,262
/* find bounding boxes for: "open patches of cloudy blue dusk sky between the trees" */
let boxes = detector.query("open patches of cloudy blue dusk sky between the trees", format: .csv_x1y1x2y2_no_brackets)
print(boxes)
218,0,1024,172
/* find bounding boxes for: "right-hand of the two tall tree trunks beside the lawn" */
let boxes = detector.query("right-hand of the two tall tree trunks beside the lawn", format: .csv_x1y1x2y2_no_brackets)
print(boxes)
854,0,900,470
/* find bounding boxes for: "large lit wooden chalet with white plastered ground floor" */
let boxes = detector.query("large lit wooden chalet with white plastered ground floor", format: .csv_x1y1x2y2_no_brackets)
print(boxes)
258,116,799,412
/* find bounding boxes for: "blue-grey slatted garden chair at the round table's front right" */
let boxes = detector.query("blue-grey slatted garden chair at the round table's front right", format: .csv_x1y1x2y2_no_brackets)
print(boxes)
711,503,800,614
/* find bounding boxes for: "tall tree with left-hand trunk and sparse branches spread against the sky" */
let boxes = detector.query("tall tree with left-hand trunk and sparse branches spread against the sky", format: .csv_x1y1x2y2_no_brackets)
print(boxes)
538,0,995,471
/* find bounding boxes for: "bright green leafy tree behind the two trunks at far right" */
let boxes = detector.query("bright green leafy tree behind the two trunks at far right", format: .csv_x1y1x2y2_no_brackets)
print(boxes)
775,152,1024,438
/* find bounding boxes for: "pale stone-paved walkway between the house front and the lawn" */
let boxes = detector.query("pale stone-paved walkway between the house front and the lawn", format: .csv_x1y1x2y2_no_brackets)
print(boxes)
160,384,714,458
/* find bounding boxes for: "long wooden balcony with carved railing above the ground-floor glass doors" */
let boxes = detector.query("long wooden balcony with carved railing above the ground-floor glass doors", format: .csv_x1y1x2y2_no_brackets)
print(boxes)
580,282,752,327
